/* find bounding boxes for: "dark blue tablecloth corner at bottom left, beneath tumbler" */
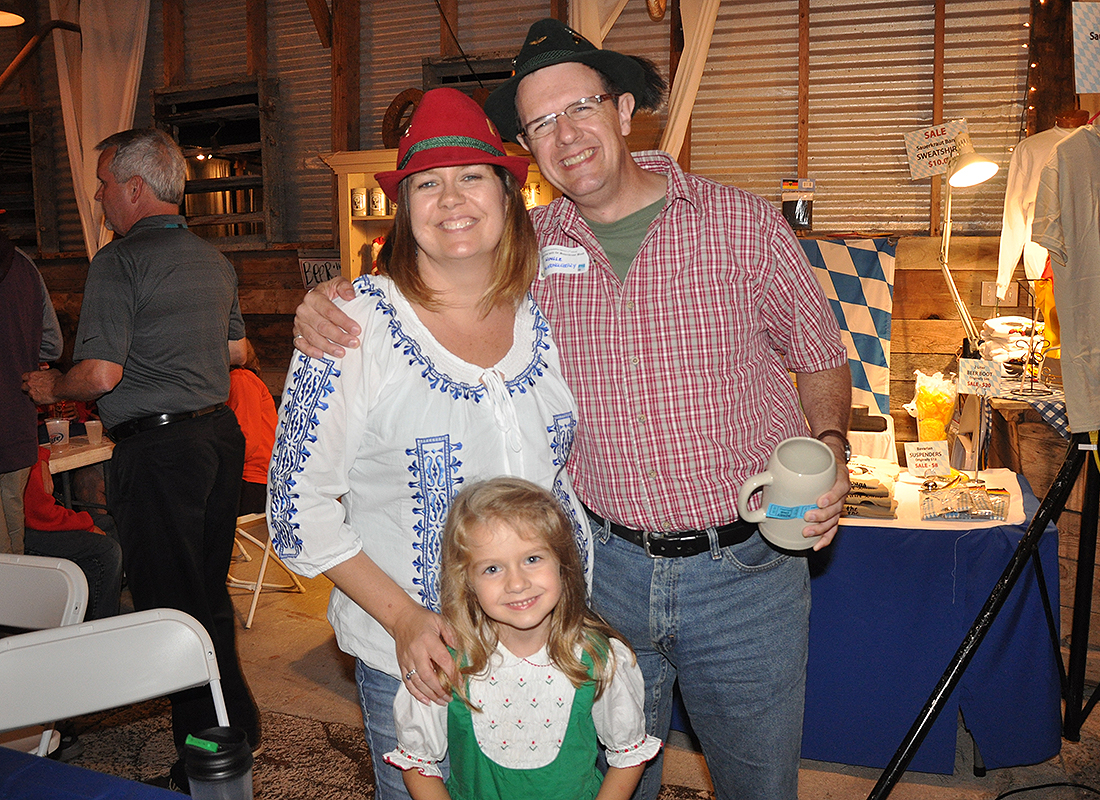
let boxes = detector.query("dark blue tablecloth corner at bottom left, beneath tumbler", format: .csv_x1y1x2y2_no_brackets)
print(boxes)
0,747,179,800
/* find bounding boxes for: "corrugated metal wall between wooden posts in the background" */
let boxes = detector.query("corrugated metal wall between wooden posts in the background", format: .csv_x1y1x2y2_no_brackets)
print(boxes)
0,0,1029,251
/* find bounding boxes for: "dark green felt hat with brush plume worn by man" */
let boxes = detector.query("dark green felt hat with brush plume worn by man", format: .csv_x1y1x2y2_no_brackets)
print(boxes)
485,19,667,142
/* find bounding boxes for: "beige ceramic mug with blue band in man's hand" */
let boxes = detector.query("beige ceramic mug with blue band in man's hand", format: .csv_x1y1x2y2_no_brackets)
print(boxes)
737,436,836,550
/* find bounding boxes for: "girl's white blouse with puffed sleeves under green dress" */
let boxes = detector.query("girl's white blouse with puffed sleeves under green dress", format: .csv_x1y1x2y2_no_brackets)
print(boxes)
384,639,661,778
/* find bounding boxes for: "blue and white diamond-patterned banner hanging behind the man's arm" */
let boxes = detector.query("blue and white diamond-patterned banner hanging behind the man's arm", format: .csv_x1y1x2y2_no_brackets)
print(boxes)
799,238,898,414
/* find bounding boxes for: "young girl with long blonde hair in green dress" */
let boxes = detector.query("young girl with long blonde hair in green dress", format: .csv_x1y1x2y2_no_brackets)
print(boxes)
385,478,661,800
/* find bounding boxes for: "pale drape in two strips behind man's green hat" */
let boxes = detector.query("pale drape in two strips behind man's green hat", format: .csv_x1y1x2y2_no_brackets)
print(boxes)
569,0,721,158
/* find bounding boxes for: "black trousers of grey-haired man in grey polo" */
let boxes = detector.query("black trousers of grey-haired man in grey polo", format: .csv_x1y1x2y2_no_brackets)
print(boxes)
108,408,260,752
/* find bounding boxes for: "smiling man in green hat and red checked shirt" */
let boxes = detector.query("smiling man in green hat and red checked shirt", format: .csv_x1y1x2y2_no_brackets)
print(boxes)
295,20,851,800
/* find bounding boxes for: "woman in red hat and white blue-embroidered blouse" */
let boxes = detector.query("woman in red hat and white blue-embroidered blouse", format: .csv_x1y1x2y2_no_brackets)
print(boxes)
268,88,592,800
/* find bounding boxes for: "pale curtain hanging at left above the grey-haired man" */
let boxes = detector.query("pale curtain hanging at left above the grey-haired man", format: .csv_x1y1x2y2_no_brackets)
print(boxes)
50,0,149,259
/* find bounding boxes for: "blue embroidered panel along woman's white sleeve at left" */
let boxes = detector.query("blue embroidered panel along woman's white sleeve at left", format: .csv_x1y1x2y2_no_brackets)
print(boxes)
268,354,340,559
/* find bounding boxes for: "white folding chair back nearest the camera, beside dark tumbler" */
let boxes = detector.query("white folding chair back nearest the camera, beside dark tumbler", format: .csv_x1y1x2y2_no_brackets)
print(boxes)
0,609,229,732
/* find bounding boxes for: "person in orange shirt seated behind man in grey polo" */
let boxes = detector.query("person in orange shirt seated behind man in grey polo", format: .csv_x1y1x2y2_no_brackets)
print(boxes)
226,342,278,515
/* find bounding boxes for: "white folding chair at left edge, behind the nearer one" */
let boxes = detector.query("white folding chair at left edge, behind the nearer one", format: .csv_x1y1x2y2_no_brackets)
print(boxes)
0,554,88,756
